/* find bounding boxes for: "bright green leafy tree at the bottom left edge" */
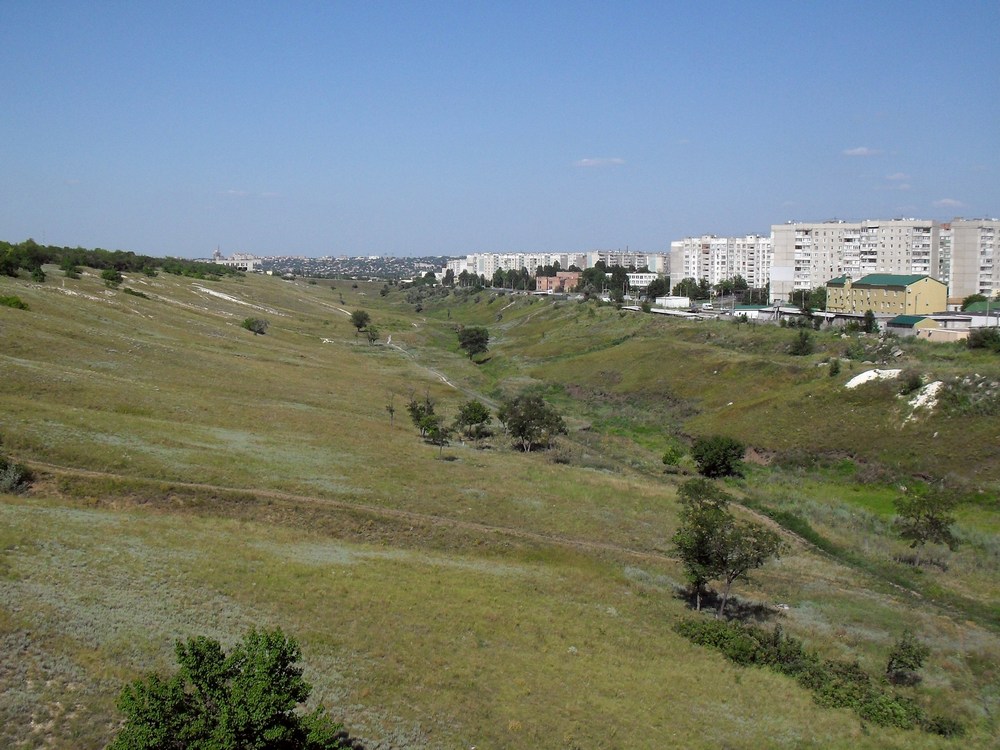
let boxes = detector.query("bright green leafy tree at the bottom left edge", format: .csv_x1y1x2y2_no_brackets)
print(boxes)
109,629,344,750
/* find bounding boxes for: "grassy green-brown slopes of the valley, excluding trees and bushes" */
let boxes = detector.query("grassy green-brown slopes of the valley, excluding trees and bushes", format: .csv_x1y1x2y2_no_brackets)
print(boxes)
0,268,1000,748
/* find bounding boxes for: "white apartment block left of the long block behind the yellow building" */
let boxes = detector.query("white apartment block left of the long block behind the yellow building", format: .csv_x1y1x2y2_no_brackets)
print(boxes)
670,234,771,287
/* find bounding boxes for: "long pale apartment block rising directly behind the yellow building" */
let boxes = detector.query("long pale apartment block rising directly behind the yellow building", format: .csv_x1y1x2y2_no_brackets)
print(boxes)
771,219,940,300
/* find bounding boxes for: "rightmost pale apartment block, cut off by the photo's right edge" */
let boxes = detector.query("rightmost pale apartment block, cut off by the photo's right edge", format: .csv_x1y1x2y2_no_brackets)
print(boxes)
947,219,1000,297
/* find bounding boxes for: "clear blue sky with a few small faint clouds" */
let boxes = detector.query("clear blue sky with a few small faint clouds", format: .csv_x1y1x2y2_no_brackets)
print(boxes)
0,0,1000,257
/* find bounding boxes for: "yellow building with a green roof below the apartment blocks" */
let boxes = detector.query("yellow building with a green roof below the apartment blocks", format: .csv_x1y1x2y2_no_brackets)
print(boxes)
826,273,948,315
